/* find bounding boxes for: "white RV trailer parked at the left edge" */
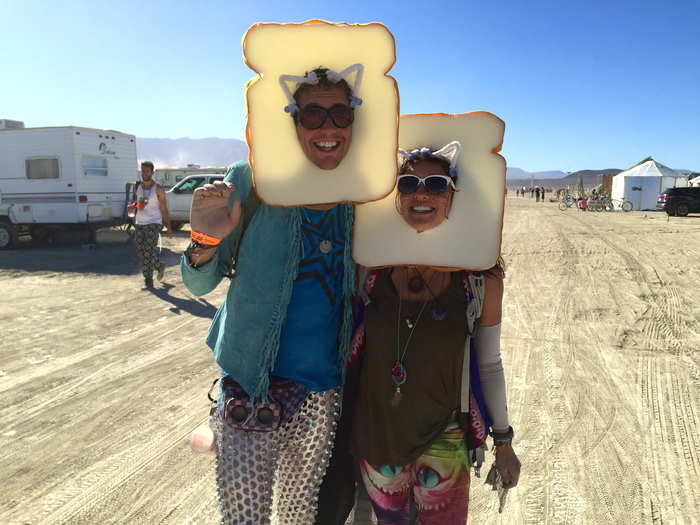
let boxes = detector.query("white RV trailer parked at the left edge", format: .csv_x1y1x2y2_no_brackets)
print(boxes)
0,126,138,249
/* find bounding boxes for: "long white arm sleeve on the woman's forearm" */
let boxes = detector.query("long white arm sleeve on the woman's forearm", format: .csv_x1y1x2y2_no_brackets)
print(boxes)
475,323,508,429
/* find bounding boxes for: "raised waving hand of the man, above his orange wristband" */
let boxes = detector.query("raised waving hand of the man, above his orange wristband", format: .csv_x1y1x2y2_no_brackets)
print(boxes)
190,181,241,239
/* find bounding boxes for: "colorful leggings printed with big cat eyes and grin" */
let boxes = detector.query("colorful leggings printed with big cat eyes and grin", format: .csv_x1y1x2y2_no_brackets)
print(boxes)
359,428,469,525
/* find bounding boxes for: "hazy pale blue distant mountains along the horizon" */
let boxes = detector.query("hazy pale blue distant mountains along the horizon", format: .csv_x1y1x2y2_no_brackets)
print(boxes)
136,138,691,187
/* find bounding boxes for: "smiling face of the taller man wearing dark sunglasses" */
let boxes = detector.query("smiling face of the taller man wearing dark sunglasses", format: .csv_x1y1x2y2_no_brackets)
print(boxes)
296,86,352,170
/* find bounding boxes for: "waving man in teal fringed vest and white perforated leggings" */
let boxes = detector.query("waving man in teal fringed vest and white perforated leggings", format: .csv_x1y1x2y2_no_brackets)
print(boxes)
180,69,355,524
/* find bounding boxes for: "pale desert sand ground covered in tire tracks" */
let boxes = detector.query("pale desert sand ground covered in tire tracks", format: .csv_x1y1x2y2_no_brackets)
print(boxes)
0,197,700,525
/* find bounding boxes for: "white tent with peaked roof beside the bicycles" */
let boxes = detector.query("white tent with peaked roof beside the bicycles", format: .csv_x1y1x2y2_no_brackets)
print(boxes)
611,157,688,210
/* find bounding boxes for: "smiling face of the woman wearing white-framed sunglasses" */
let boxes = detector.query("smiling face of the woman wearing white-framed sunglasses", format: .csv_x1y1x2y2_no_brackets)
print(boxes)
398,159,453,232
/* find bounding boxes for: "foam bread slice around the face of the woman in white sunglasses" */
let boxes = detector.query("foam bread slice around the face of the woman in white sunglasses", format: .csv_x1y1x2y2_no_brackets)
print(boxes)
353,111,506,270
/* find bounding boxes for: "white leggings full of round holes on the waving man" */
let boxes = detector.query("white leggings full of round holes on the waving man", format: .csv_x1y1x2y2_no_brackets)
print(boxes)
210,390,339,525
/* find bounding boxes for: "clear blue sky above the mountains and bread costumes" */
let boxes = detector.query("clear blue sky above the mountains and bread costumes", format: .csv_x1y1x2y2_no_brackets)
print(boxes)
0,0,700,171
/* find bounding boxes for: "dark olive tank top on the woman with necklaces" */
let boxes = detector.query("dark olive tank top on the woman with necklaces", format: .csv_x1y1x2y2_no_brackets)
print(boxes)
353,270,467,465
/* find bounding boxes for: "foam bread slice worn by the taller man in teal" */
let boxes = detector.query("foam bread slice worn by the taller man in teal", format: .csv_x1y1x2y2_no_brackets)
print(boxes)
243,20,399,206
